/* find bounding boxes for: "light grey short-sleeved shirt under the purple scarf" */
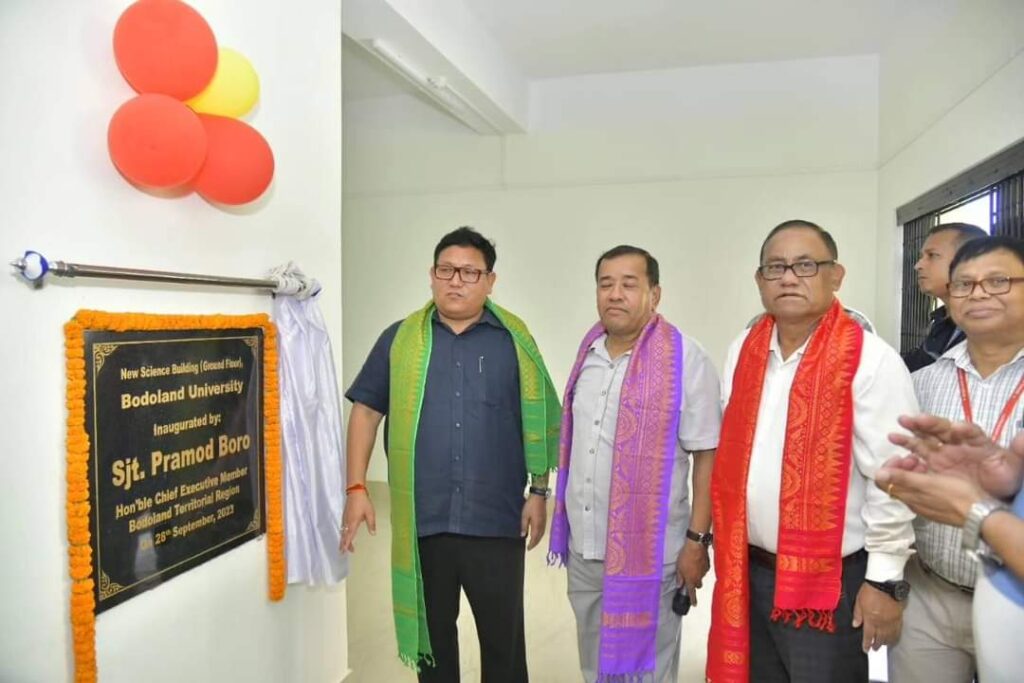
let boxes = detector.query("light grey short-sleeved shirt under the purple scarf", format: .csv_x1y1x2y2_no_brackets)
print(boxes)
565,327,722,563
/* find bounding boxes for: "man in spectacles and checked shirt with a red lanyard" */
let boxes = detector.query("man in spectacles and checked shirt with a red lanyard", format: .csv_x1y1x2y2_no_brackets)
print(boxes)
889,237,1024,683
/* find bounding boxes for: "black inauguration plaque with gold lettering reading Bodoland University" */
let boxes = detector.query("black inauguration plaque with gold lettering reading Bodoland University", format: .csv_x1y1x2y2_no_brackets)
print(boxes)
85,328,266,613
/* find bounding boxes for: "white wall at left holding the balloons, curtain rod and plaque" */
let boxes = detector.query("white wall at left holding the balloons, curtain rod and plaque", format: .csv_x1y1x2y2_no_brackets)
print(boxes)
0,0,347,683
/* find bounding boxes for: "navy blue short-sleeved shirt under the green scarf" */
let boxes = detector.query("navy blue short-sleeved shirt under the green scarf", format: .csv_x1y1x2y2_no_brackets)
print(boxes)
345,309,526,539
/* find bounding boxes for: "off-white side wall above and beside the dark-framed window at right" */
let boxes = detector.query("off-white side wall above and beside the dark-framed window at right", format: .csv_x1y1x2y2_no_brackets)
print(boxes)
876,0,1024,341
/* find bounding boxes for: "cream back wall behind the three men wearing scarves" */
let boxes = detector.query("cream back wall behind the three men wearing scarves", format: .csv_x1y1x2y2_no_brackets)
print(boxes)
343,57,878,479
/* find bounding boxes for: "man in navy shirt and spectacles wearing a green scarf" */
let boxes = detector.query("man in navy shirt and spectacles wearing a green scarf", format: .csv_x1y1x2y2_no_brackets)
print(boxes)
341,227,560,683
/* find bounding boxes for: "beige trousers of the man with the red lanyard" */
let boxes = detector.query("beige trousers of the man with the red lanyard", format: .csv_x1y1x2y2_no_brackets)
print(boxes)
889,556,976,683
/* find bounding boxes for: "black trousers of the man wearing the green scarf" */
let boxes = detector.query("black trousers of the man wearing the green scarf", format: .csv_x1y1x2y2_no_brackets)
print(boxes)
420,533,528,683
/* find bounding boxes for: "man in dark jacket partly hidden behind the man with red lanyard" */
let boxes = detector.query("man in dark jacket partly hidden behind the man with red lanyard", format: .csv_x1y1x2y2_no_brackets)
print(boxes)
903,223,988,373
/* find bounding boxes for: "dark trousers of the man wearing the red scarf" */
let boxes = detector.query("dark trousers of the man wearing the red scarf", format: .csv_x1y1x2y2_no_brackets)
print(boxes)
751,553,867,683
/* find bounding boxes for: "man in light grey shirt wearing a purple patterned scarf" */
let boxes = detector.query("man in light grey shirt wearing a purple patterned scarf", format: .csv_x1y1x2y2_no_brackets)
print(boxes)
551,245,721,683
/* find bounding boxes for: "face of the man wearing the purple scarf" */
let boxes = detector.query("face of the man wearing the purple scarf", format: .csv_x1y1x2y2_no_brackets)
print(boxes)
597,254,662,336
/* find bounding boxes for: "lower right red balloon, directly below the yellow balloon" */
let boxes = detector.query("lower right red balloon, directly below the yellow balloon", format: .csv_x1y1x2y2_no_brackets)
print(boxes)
195,114,273,205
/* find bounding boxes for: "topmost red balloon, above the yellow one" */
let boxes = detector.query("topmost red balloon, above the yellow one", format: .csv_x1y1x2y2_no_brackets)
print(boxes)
114,0,217,100
